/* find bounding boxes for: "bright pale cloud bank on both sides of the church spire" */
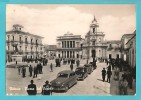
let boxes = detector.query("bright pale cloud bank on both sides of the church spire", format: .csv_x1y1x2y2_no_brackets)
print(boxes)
6,4,135,44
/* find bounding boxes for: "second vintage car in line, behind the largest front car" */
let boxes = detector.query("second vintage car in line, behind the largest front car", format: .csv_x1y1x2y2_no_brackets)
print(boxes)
75,67,88,80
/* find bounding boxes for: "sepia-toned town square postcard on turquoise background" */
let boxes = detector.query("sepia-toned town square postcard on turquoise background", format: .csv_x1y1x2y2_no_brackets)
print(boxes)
5,4,136,96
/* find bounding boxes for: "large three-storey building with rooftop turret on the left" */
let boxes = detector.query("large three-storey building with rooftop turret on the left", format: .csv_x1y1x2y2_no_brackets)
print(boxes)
6,24,44,61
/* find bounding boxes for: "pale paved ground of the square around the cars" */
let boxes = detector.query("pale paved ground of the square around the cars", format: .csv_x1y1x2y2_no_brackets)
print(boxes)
6,60,110,95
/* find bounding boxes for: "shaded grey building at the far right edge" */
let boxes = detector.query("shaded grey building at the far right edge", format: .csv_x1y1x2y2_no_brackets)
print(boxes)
126,31,136,67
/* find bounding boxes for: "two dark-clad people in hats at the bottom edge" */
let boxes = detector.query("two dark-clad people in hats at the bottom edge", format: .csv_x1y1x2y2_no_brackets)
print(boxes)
27,80,53,95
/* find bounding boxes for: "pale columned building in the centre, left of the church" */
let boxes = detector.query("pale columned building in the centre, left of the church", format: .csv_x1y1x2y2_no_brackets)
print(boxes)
56,32,82,58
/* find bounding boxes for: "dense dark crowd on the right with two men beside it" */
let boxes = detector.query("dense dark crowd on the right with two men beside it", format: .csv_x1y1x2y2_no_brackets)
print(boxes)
102,58,136,95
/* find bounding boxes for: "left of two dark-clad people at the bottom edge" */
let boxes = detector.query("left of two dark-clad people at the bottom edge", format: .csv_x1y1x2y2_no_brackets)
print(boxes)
27,80,37,95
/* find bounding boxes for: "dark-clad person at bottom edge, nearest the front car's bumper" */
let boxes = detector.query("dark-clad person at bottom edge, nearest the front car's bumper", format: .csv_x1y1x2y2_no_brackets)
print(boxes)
42,81,52,95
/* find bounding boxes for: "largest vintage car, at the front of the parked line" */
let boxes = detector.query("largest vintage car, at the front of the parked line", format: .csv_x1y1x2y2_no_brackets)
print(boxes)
50,70,77,92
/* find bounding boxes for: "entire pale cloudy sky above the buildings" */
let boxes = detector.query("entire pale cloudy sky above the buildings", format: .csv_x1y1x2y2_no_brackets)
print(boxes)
6,4,136,45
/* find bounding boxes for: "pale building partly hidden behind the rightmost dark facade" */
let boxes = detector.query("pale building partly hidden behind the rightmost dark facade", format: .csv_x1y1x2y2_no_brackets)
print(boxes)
121,34,133,61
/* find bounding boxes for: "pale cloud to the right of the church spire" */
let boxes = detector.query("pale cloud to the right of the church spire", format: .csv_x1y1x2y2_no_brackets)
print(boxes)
99,15,136,40
